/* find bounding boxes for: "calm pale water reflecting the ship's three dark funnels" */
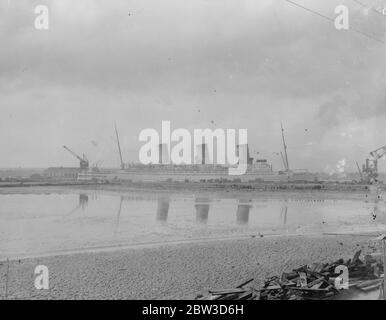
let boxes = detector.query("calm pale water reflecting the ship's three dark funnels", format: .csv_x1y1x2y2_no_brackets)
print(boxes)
0,192,386,259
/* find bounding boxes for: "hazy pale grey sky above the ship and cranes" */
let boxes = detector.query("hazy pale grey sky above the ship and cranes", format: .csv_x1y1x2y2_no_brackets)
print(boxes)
0,0,386,171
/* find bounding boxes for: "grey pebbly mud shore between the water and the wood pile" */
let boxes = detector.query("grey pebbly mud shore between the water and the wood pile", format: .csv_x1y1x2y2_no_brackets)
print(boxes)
0,235,380,299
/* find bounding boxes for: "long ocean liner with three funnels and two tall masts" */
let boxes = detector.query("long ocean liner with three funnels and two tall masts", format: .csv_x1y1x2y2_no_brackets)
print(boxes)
78,126,314,182
